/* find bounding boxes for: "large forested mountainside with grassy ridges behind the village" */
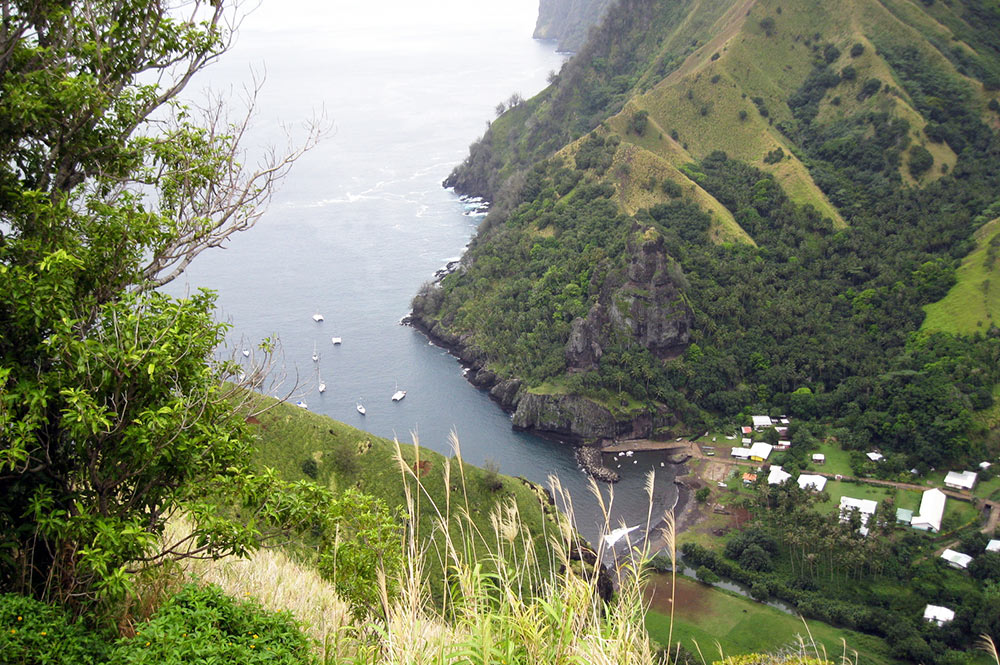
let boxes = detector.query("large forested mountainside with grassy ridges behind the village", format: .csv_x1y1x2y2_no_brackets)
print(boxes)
414,0,1000,464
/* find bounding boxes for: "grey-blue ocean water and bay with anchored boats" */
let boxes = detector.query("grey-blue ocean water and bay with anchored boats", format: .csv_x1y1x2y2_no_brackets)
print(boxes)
169,0,676,542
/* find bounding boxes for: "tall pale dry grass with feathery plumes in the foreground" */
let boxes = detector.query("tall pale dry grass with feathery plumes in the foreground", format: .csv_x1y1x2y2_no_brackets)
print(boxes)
166,437,675,665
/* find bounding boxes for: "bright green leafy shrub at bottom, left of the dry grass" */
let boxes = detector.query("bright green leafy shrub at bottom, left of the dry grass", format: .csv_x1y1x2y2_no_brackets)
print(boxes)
108,585,316,665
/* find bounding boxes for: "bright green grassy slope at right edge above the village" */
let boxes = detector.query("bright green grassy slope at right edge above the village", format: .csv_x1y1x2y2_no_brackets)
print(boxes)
921,219,1000,334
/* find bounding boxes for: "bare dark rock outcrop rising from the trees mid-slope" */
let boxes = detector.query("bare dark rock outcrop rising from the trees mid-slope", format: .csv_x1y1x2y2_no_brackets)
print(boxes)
566,230,693,372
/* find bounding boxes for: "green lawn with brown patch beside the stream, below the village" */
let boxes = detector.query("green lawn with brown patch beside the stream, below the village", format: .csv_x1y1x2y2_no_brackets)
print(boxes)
646,575,897,665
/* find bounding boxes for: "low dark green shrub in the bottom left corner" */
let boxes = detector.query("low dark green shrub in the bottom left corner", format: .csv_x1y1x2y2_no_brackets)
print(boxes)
0,594,110,665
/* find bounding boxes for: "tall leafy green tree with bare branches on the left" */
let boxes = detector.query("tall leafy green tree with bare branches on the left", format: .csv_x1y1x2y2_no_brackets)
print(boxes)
0,0,322,602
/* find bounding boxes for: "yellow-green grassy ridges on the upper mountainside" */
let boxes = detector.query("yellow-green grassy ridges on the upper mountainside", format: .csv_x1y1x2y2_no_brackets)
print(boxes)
568,0,992,242
